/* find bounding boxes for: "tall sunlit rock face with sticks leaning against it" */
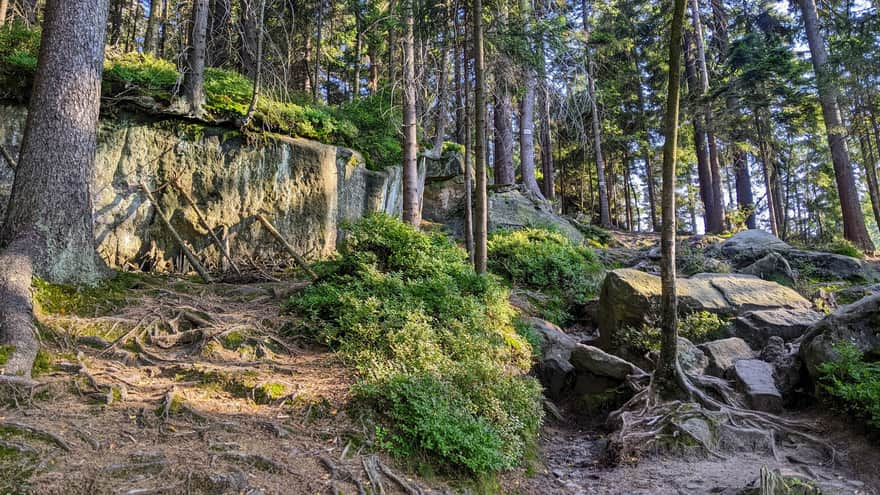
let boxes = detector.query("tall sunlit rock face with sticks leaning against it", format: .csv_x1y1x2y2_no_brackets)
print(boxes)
0,106,401,274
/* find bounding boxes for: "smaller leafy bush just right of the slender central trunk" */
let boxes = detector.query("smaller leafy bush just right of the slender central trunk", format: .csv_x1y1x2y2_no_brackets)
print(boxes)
488,228,604,324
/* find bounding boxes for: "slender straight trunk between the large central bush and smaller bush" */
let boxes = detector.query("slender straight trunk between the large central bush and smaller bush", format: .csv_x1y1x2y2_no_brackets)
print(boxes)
471,0,489,274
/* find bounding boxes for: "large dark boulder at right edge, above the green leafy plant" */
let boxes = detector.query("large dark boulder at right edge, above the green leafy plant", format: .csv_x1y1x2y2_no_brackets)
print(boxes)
801,294,880,378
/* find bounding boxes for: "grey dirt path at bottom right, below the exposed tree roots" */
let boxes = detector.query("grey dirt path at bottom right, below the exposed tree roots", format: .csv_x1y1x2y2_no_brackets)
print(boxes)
523,408,880,495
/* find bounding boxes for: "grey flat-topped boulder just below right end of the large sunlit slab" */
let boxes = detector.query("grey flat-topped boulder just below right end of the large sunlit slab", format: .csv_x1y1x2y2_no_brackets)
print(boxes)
733,308,822,350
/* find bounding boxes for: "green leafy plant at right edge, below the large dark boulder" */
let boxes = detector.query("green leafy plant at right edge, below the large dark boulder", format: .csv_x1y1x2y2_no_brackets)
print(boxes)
819,342,880,429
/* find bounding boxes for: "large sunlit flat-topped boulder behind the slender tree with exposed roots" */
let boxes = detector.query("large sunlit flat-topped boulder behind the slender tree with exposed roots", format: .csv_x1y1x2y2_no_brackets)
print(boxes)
598,269,810,350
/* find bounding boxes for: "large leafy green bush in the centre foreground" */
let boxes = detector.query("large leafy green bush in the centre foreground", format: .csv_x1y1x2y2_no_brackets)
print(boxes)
290,215,542,474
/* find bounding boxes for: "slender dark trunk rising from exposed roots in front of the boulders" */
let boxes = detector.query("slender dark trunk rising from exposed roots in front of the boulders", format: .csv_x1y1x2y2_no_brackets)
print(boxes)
654,0,685,396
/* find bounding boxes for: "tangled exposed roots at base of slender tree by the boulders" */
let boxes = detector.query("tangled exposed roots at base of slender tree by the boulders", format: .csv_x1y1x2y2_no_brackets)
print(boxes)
604,360,836,465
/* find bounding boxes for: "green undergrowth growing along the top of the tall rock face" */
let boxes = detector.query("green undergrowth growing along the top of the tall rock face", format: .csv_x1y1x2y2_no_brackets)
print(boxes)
0,22,403,169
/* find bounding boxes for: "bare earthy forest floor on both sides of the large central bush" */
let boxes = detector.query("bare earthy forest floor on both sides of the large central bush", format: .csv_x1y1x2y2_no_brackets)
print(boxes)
0,240,880,495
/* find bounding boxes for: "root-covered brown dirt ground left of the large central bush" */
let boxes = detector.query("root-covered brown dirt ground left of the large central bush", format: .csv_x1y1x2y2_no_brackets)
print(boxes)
0,280,432,495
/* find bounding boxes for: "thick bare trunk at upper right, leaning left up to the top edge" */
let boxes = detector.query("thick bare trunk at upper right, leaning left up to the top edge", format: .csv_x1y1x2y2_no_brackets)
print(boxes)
798,0,874,251
